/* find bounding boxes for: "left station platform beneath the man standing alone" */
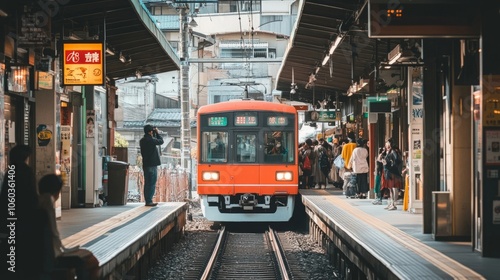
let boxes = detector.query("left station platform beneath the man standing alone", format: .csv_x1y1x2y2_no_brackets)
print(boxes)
58,202,188,279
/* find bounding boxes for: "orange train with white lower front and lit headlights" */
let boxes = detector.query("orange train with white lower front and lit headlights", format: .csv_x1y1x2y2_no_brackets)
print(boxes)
197,99,299,222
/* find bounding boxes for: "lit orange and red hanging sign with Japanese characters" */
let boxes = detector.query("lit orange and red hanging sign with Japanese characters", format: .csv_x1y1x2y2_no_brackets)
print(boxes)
62,41,104,86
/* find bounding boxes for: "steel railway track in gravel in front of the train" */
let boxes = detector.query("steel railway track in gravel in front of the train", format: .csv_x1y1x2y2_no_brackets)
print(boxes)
189,227,294,280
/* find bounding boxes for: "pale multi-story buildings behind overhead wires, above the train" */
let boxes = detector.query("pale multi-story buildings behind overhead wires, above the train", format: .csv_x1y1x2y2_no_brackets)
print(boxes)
144,0,297,111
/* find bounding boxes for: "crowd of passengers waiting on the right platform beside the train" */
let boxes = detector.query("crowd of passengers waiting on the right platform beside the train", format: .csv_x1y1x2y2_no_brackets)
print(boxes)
298,131,408,211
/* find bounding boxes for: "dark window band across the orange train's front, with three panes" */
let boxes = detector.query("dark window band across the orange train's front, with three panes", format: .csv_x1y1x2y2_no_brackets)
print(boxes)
200,113,297,164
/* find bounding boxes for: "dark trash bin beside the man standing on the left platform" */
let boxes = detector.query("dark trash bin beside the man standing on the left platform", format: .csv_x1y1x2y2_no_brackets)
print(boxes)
106,161,130,205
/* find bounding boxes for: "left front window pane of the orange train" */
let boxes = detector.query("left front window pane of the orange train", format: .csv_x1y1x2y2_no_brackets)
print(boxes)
201,131,228,162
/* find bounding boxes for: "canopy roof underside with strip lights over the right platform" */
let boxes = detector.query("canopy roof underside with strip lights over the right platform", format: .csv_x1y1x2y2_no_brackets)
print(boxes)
276,0,389,103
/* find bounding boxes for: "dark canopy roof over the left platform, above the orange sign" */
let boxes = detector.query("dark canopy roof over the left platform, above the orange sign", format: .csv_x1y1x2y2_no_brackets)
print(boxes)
0,0,180,80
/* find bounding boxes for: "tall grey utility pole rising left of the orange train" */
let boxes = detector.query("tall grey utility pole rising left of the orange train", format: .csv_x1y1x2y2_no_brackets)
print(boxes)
180,5,191,173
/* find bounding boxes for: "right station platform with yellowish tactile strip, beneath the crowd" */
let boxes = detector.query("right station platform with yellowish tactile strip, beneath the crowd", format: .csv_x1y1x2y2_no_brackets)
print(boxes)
300,189,500,279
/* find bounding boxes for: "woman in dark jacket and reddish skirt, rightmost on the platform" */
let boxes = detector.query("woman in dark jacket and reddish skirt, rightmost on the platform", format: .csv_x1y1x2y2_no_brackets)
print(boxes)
382,139,403,210
